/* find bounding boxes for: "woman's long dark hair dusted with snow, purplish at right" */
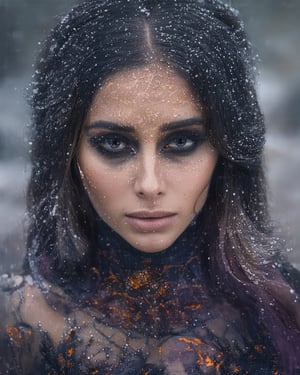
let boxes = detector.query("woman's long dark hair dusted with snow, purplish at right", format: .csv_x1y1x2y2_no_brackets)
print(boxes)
25,0,300,373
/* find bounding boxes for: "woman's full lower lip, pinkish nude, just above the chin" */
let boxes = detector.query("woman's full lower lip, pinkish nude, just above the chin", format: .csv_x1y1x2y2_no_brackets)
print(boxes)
126,215,176,233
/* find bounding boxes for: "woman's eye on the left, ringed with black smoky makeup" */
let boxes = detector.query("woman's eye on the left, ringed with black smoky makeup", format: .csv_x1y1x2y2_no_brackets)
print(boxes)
88,133,137,158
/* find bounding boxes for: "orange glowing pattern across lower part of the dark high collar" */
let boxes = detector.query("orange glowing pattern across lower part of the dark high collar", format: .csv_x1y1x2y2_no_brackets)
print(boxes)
85,252,207,336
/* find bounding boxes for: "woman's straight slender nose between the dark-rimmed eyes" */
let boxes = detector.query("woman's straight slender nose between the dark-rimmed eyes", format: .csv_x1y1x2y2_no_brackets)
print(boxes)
134,151,165,199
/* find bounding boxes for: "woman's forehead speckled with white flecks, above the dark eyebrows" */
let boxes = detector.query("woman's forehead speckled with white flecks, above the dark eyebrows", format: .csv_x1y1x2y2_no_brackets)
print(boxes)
87,64,202,128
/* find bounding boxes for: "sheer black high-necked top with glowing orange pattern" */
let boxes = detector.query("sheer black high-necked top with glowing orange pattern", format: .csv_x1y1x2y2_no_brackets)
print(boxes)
0,225,281,375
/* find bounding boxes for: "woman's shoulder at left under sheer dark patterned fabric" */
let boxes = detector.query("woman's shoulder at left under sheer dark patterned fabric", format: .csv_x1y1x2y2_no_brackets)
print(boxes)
0,274,70,374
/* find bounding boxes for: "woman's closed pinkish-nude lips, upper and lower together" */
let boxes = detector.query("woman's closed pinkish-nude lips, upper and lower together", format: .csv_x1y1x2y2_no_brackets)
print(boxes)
125,211,176,233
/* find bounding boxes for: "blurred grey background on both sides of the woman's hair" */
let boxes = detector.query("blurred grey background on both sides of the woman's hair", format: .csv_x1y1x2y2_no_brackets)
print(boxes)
0,0,300,273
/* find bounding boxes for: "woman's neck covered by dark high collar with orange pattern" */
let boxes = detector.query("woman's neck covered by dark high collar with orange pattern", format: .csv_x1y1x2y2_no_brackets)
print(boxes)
89,214,209,337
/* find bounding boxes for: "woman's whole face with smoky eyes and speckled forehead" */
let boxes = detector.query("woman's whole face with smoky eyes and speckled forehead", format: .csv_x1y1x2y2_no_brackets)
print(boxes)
78,65,217,253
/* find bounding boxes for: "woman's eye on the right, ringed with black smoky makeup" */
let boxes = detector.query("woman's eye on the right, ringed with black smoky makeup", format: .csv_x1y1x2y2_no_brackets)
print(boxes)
161,130,207,156
